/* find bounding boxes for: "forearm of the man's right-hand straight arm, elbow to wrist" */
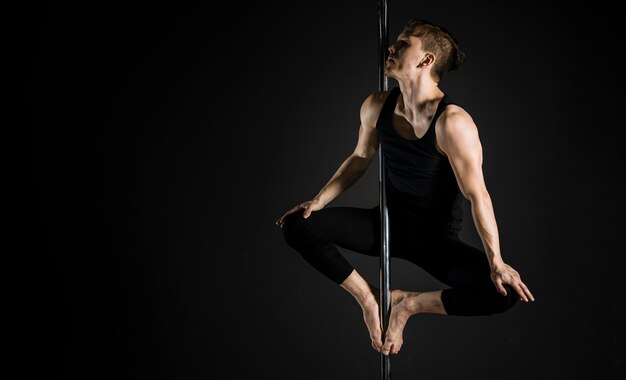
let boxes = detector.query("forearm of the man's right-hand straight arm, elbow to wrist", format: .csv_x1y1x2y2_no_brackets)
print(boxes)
470,193,503,268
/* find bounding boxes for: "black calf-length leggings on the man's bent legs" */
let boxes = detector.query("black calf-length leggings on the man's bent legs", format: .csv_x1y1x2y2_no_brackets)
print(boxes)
282,206,518,316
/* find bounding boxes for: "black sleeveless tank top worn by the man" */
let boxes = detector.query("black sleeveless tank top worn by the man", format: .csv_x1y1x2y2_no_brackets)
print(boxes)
376,87,465,231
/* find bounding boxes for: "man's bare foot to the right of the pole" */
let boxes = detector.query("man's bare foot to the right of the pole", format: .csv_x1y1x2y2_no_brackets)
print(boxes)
382,289,420,355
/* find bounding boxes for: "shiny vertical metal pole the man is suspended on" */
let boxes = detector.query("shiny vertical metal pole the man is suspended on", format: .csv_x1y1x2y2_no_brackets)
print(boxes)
378,0,391,380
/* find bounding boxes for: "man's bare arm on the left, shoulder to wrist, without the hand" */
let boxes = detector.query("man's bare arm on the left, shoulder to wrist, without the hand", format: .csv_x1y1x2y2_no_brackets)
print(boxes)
314,92,386,206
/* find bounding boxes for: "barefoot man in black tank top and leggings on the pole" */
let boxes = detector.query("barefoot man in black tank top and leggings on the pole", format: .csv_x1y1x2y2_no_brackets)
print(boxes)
276,19,535,355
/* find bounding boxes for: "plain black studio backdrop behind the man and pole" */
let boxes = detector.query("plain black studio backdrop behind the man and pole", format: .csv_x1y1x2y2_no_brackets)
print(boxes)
35,1,626,380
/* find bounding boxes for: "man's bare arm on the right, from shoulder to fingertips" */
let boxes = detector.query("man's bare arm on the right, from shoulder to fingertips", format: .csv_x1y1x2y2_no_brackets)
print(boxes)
437,109,534,301
